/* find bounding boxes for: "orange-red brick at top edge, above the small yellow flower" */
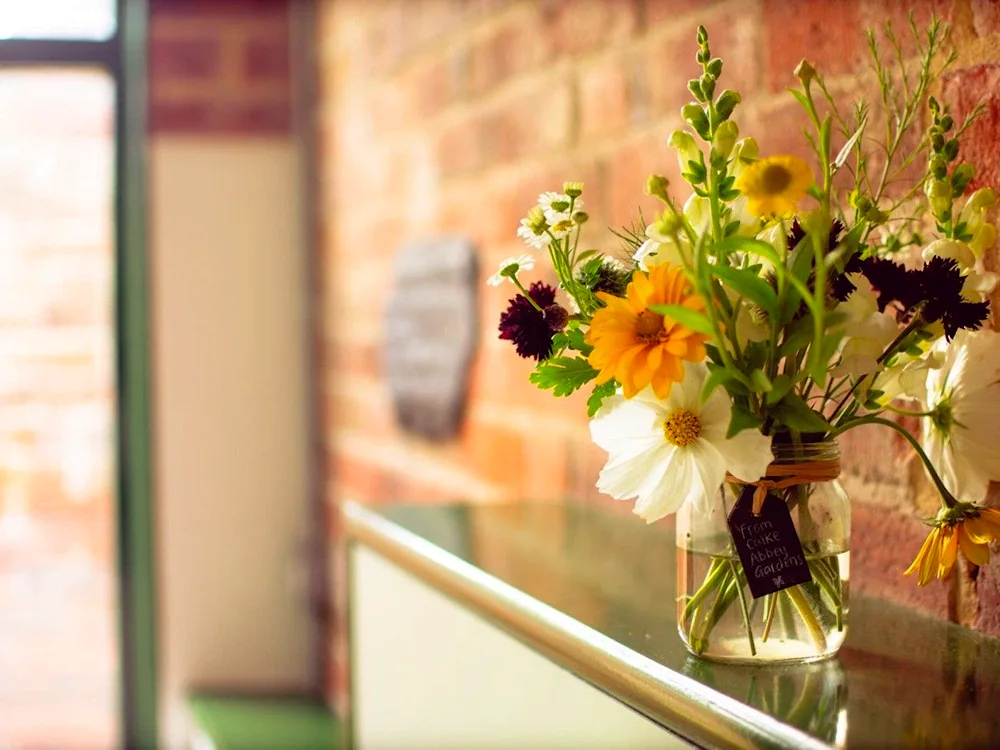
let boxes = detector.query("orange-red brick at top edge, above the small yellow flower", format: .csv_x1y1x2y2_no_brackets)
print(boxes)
763,0,867,91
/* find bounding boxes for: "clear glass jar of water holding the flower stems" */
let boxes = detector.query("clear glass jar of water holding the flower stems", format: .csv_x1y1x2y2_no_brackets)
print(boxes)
677,441,851,663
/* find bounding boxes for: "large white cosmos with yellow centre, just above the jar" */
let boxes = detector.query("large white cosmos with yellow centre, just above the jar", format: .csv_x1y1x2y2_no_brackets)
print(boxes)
590,362,772,523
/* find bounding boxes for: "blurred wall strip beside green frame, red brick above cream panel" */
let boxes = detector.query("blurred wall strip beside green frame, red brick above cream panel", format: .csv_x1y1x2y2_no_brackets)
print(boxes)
149,0,317,747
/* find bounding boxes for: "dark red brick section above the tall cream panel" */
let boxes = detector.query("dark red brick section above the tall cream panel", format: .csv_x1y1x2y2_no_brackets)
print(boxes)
149,0,291,136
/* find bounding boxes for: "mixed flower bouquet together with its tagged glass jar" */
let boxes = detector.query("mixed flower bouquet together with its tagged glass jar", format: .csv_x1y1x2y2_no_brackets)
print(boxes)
489,19,1000,661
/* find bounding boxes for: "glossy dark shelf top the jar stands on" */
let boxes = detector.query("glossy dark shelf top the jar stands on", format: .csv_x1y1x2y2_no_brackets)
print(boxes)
380,503,1000,748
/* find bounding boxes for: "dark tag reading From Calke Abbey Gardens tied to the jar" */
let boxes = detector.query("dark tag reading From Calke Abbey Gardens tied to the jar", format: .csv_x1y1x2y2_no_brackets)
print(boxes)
729,485,812,599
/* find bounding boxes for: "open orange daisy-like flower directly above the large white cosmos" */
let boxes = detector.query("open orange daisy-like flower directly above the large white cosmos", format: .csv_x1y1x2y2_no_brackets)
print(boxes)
587,263,708,399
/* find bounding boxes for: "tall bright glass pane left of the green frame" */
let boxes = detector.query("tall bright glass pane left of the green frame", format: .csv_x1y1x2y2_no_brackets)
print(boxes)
0,69,119,750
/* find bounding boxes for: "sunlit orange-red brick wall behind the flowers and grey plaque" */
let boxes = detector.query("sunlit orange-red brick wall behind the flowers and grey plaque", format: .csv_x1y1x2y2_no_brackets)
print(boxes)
319,0,1000,716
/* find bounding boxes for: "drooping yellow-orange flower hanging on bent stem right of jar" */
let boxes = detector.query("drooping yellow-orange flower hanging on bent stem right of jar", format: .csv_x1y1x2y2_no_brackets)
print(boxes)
903,506,1000,586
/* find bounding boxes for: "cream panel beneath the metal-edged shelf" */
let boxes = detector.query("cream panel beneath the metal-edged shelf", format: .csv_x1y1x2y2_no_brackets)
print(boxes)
351,546,691,750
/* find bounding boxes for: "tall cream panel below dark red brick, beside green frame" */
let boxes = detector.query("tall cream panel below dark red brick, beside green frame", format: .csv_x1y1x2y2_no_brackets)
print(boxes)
150,137,310,748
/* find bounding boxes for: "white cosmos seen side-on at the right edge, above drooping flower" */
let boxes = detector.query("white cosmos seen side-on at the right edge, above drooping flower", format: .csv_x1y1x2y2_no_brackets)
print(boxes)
923,329,1000,502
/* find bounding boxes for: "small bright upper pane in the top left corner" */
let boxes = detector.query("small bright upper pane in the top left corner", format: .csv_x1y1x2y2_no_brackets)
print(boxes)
0,0,115,39
